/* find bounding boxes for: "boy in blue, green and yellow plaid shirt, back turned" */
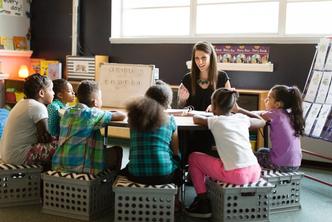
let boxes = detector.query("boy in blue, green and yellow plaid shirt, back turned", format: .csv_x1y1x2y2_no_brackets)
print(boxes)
52,80,125,174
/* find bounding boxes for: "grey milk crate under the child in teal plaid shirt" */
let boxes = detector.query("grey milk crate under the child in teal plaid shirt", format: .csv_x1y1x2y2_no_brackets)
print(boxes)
113,176,177,222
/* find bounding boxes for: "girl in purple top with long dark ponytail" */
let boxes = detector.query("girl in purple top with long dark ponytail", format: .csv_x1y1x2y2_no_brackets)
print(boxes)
256,85,305,172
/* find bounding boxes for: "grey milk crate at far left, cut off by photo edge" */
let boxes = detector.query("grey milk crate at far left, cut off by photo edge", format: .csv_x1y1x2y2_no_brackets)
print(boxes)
0,164,42,207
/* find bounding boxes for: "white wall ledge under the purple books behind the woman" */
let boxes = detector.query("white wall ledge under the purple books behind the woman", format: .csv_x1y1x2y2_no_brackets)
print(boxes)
186,61,273,72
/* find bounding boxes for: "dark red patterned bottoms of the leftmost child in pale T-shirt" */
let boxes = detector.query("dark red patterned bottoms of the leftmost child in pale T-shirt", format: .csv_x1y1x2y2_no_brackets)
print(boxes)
24,140,57,171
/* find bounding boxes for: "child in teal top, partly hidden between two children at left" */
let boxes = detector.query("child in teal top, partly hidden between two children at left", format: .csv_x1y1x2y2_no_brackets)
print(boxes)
47,79,75,138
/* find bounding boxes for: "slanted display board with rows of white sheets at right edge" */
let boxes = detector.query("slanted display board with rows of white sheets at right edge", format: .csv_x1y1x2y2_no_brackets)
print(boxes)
303,38,332,142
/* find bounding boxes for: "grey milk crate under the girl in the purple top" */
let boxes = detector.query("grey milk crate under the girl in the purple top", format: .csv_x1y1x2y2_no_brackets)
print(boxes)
262,170,304,213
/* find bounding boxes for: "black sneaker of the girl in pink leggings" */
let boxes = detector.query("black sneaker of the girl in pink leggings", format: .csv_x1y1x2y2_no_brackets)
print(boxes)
185,197,212,218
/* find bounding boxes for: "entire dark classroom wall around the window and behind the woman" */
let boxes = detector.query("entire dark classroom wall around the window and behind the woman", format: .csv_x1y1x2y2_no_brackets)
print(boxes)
31,0,332,163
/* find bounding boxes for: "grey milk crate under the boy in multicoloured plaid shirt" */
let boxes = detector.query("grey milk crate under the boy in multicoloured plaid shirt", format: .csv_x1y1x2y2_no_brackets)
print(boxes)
42,171,116,220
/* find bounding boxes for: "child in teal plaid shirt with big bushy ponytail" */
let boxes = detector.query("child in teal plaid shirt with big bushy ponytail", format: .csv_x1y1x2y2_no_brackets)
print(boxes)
122,80,180,185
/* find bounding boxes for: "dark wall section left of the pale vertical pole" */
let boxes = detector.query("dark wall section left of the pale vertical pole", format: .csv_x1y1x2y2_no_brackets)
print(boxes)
30,0,72,62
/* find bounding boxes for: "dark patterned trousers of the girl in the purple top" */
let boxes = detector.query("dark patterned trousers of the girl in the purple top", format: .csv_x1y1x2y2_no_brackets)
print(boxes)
255,148,299,172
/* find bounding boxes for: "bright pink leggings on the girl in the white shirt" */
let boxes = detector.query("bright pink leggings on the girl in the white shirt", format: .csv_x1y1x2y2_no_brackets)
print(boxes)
188,152,261,194
